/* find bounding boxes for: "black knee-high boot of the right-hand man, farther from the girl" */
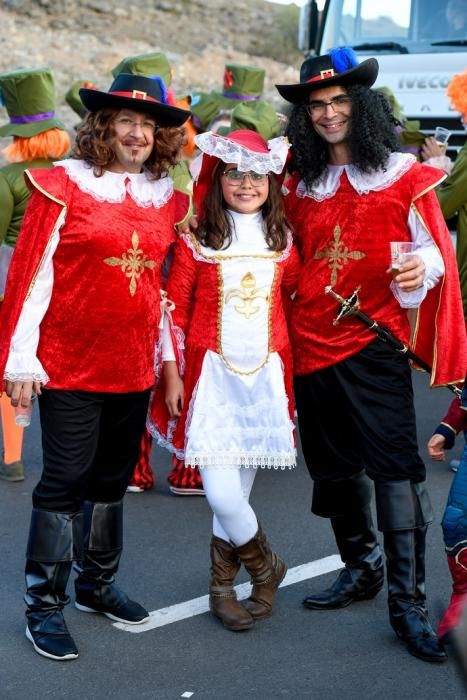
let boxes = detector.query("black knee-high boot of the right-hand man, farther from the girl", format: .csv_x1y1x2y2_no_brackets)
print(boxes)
375,480,447,662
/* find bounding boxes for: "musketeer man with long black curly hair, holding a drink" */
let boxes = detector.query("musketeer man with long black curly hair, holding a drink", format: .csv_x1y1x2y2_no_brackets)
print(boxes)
277,48,467,661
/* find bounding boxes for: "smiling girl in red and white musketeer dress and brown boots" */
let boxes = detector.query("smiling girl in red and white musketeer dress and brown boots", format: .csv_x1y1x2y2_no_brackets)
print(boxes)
149,130,299,630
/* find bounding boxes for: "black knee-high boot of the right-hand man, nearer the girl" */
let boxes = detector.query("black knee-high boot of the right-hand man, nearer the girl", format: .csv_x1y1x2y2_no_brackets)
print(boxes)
303,472,384,610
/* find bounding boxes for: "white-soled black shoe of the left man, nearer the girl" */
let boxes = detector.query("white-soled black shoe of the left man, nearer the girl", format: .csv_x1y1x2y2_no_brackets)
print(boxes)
75,580,149,625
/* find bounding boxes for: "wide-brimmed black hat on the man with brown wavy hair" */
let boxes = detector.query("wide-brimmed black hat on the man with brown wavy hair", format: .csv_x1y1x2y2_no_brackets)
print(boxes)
79,73,191,126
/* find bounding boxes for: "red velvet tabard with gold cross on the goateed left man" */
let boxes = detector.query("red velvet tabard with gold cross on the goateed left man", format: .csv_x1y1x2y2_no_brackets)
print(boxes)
33,169,176,392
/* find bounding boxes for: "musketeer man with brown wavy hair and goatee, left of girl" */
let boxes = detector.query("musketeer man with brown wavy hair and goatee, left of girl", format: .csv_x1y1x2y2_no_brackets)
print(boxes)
0,74,190,661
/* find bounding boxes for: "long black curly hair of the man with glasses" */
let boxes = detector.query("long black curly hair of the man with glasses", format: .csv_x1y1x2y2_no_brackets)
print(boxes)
286,85,400,189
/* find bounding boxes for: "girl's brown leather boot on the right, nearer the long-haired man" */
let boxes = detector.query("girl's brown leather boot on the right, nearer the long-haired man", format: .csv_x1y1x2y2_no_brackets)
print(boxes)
235,527,287,620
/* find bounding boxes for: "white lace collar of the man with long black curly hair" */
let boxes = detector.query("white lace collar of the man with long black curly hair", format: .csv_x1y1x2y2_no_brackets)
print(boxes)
296,153,416,202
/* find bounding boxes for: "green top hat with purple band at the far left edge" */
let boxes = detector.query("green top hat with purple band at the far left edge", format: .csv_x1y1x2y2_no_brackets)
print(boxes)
0,68,66,137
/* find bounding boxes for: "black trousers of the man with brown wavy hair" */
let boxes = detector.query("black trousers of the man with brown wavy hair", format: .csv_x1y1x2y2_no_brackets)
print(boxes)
32,388,150,513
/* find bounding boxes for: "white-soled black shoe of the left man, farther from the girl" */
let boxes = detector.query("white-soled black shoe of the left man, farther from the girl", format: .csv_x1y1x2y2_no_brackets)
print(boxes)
26,610,79,661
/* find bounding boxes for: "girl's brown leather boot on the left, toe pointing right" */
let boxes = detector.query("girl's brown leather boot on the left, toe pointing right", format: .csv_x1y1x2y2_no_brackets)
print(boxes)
209,535,255,632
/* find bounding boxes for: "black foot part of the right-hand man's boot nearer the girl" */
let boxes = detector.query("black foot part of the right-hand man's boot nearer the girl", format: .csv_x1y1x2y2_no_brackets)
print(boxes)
303,566,384,610
